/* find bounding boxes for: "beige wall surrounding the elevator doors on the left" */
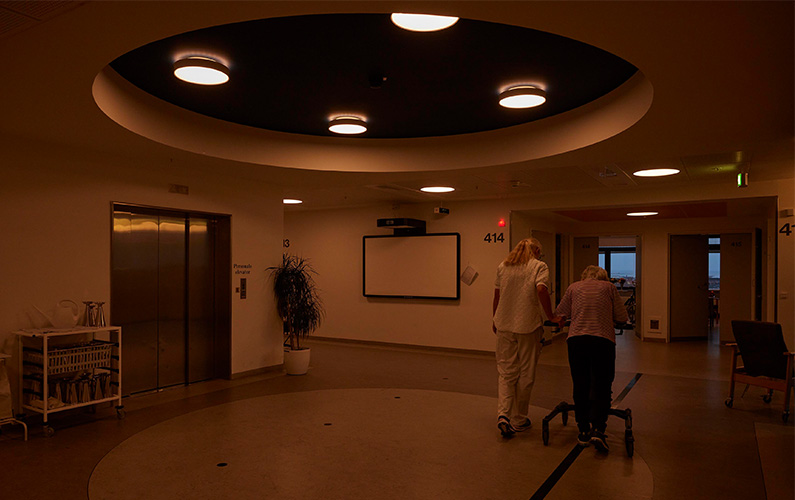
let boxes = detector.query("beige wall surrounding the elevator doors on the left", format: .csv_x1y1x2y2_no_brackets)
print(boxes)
0,146,283,380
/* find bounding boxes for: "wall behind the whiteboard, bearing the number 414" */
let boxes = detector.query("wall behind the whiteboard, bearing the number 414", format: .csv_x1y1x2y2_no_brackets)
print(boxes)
285,202,510,350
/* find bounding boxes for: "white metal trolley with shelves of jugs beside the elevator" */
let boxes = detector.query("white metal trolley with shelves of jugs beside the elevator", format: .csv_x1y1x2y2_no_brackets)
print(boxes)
14,326,125,437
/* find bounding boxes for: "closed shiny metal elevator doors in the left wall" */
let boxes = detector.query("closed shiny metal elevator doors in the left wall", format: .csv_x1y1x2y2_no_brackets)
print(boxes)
111,204,231,395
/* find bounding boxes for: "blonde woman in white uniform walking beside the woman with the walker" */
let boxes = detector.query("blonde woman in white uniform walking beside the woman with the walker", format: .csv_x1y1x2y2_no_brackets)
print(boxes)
492,238,559,438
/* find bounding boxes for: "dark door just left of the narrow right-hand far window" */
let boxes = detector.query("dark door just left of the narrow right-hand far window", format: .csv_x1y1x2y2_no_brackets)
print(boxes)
668,234,712,341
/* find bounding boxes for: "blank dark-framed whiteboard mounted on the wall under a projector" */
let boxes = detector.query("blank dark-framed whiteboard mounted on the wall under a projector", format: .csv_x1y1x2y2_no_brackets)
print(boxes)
362,233,461,300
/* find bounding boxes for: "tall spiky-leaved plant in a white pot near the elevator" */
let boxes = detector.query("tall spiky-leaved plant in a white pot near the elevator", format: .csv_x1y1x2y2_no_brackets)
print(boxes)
268,254,325,375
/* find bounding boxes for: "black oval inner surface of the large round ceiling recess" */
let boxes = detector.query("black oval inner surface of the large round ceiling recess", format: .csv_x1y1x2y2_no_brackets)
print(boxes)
110,14,637,140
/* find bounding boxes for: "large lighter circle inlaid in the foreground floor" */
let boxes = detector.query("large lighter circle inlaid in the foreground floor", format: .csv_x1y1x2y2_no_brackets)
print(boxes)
89,389,652,500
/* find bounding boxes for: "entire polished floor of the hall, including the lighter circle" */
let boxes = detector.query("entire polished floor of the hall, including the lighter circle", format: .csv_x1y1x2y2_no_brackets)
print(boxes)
0,332,795,500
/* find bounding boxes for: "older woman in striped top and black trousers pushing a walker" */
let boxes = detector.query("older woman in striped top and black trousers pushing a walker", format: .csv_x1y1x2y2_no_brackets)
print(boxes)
555,266,628,452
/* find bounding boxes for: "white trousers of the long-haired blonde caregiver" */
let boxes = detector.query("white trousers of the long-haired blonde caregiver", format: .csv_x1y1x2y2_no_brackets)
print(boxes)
497,327,544,424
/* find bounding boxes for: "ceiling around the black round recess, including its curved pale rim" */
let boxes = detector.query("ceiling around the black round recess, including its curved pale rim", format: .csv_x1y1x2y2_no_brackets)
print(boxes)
0,1,795,210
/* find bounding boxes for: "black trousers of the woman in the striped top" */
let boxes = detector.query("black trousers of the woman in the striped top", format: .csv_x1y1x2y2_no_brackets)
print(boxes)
566,335,616,432
